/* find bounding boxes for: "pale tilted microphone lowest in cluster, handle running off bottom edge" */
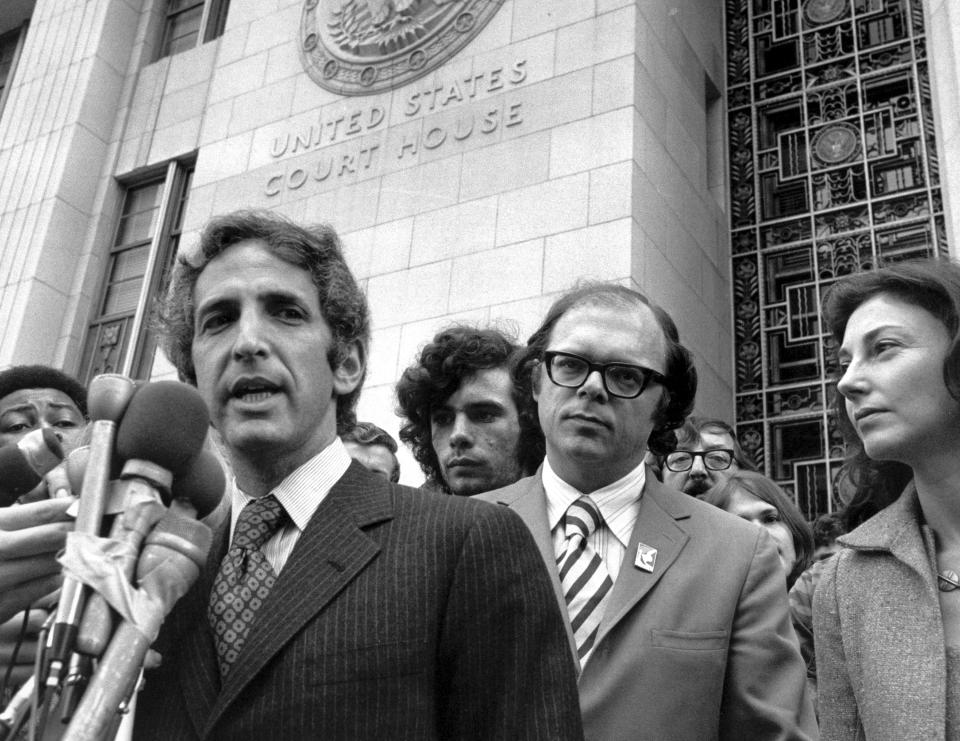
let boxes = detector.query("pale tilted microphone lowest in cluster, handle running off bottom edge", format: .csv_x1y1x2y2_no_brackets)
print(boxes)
63,512,213,741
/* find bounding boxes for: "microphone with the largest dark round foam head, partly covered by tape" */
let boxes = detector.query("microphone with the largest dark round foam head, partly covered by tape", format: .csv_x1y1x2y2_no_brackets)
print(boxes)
77,381,210,657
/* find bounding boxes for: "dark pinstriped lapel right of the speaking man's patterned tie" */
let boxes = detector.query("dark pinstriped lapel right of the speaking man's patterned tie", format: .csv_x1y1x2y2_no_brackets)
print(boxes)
205,463,393,732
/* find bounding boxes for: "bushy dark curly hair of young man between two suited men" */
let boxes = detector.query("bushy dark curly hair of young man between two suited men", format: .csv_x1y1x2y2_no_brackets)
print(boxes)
397,325,544,491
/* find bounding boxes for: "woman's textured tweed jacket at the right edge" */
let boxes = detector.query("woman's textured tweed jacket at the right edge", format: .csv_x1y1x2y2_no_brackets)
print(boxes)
813,486,947,741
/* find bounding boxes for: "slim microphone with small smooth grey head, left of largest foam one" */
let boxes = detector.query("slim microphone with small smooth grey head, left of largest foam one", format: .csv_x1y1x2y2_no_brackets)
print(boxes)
46,373,136,688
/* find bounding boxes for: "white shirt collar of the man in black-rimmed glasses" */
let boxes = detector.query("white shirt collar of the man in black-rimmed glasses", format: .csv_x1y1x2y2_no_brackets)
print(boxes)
541,458,647,548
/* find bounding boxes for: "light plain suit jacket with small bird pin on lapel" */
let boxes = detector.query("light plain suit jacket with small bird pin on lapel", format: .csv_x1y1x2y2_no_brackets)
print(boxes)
478,469,817,741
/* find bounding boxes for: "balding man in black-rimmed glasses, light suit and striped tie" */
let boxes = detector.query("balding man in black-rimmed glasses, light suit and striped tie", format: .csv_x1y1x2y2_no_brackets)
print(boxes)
477,283,817,741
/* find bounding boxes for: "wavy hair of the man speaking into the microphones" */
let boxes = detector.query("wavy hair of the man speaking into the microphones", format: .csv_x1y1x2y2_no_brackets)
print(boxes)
156,211,370,431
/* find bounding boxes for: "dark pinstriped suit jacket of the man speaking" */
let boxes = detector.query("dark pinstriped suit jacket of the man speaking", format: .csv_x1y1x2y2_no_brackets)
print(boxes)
135,463,582,741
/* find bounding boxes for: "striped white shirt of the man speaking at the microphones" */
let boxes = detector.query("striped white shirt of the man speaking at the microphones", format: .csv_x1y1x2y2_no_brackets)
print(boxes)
230,437,350,574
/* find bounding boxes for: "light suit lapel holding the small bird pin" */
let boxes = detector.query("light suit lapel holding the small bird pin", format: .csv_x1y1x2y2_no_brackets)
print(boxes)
597,474,690,643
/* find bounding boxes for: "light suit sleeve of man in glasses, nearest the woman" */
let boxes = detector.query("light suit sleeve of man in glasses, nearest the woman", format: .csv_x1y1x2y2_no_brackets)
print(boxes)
717,531,818,741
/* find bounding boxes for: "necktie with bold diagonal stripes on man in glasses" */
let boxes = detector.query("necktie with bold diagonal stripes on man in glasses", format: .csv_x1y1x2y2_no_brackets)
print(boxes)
557,497,613,666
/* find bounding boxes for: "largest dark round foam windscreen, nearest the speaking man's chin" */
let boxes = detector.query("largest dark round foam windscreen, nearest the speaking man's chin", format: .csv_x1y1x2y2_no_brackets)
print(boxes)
117,381,208,476
